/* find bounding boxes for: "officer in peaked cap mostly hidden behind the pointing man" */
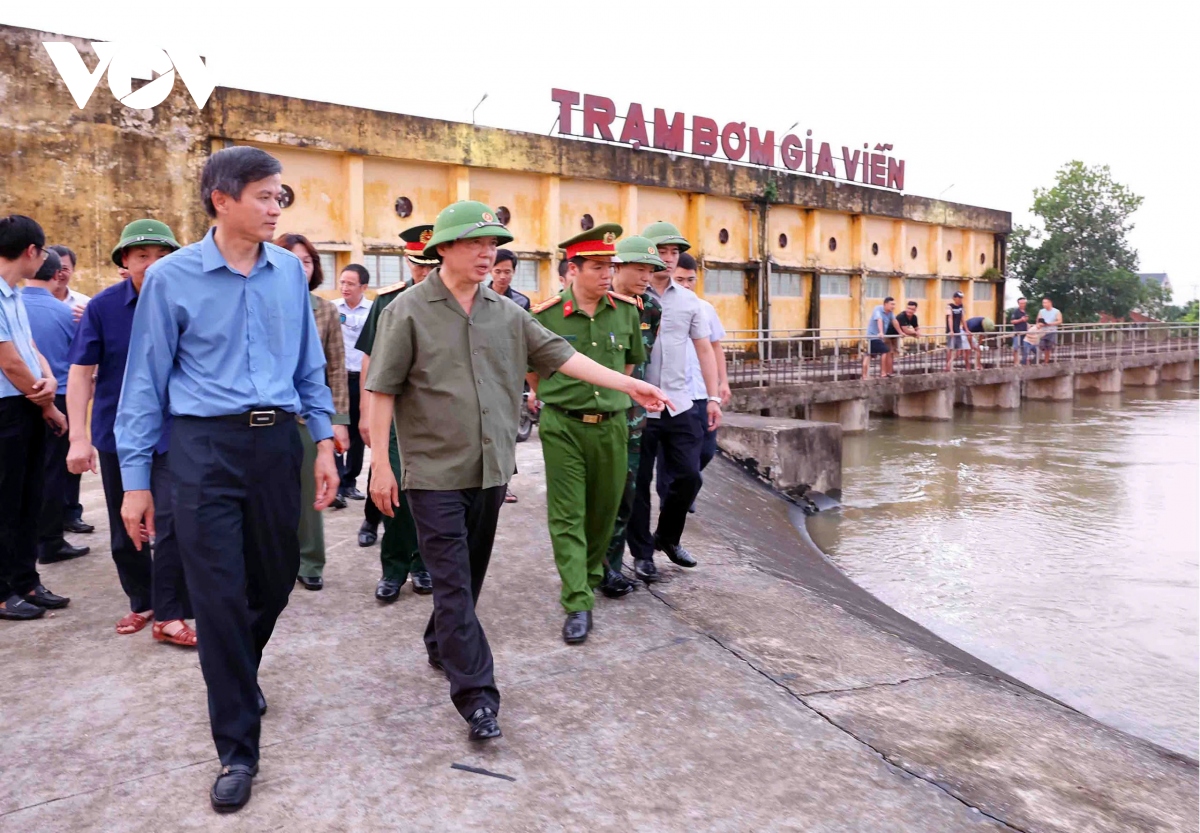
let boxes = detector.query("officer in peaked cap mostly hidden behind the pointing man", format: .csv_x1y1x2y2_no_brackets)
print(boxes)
354,226,439,604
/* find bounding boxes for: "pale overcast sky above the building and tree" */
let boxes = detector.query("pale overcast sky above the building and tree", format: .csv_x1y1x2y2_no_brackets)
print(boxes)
0,0,1200,301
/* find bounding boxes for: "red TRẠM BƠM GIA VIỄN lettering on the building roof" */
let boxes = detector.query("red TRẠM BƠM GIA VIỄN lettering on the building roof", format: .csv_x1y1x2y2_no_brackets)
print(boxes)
550,88,904,191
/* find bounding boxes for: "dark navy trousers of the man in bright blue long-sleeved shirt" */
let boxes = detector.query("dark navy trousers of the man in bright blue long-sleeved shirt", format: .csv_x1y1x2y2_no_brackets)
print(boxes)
168,415,304,766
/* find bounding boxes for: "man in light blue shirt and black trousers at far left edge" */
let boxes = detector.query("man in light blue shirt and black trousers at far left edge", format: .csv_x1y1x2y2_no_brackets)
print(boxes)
0,214,71,619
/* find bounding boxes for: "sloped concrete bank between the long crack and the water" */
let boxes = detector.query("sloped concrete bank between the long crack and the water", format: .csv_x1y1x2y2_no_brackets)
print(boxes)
676,460,1198,831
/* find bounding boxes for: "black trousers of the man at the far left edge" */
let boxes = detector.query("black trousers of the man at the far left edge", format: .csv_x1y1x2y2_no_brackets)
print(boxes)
0,396,46,600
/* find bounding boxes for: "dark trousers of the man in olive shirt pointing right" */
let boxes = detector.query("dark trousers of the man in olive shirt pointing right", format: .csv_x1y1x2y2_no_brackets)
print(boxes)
404,486,505,720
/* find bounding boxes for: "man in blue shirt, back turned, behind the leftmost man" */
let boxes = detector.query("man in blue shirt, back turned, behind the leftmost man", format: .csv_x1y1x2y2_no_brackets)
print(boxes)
20,250,89,564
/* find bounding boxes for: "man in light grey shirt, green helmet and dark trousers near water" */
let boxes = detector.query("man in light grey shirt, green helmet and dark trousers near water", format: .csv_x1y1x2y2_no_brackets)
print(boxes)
628,222,721,582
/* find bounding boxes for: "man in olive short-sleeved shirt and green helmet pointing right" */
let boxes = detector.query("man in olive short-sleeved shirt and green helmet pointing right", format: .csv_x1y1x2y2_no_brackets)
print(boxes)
366,200,668,741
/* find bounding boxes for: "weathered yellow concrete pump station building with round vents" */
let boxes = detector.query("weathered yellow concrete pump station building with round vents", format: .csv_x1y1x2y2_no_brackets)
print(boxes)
0,28,1012,338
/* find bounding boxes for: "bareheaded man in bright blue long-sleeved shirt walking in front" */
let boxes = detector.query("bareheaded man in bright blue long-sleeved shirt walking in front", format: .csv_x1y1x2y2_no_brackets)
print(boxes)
116,146,338,813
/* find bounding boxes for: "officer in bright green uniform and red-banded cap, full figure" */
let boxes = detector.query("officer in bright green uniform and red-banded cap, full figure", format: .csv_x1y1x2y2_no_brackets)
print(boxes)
530,223,646,645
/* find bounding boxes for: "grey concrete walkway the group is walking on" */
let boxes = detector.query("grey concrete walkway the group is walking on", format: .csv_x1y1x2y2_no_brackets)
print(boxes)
0,436,1198,833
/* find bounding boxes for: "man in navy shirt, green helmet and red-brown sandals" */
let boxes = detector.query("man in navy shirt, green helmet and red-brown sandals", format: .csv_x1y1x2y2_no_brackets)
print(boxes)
67,220,196,647
